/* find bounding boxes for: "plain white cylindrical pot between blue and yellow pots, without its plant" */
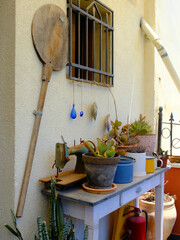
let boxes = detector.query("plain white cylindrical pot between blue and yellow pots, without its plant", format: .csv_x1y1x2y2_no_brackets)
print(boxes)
126,152,146,177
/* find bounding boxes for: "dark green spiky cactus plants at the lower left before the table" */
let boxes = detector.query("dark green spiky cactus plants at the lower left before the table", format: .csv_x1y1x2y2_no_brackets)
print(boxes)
4,178,88,240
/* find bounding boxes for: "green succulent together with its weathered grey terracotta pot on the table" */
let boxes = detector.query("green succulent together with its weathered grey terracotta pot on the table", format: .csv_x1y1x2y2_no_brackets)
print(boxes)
82,138,120,189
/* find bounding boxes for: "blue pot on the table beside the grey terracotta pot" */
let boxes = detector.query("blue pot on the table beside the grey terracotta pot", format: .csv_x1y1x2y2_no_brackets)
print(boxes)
114,156,134,183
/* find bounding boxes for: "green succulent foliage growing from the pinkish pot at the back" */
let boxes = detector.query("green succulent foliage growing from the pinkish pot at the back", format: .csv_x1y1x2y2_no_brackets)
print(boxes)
129,114,152,136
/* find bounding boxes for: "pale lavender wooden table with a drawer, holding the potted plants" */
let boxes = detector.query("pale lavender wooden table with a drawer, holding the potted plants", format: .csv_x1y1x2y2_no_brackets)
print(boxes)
43,167,169,240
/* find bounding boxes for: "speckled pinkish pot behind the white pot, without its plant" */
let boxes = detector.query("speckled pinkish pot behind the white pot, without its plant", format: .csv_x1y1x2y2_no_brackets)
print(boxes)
131,134,156,156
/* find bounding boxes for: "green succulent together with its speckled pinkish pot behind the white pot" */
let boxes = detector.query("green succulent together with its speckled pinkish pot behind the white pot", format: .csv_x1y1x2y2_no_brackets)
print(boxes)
129,114,156,156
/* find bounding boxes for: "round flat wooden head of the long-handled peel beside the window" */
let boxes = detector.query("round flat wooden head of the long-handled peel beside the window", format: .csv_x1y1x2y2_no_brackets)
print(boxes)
32,4,68,70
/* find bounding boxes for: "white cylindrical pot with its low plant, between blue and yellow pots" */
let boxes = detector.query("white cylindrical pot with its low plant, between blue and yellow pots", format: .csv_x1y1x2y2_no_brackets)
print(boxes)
126,147,146,177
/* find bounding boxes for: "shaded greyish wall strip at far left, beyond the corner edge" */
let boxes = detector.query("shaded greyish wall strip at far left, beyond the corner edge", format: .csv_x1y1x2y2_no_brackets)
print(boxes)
0,0,15,239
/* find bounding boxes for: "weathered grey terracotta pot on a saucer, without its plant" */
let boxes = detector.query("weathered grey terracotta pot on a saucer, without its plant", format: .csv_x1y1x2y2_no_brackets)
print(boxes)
82,153,120,189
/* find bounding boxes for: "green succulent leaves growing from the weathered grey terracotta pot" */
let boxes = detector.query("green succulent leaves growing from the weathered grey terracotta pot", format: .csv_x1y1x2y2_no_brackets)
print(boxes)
83,138,116,158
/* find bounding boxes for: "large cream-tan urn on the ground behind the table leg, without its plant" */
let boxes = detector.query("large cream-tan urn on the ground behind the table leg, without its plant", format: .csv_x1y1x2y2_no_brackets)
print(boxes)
139,197,177,240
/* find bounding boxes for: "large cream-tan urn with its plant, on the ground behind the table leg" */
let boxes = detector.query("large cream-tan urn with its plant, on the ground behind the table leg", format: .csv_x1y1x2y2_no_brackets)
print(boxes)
139,189,177,240
